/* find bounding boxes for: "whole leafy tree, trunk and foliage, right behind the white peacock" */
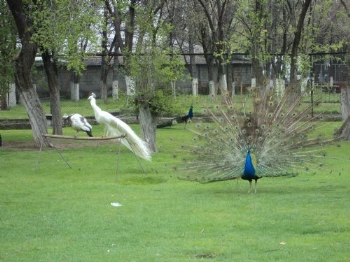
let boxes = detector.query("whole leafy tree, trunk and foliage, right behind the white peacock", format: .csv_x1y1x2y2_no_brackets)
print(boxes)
127,3,184,152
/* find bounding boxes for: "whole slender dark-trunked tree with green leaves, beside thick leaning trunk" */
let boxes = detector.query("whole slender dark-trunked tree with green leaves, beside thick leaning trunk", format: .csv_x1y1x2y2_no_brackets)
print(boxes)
32,0,99,134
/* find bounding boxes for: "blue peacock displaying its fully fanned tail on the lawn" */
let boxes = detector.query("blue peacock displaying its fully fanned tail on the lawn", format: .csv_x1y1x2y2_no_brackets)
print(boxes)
176,89,335,192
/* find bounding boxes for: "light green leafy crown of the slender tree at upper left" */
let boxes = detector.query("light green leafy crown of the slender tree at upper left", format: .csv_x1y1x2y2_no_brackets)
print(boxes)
30,0,102,75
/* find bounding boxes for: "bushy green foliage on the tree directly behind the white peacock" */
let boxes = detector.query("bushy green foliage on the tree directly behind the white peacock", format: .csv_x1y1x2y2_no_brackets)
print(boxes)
123,9,185,116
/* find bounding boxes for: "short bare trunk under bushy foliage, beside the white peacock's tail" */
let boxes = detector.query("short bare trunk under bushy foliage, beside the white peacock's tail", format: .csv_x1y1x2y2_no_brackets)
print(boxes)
139,104,158,153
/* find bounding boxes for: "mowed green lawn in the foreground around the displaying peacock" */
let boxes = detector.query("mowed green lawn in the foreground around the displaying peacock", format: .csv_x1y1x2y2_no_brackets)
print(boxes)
0,124,350,261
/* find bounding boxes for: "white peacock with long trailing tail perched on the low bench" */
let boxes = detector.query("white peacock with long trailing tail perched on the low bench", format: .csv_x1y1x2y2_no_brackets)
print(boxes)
88,94,151,161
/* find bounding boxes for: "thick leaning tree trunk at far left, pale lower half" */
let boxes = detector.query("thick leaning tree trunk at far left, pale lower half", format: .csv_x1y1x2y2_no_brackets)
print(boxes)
7,0,51,147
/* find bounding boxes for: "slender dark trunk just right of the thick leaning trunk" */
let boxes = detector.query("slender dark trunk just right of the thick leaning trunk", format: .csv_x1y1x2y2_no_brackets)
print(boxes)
42,51,62,135
